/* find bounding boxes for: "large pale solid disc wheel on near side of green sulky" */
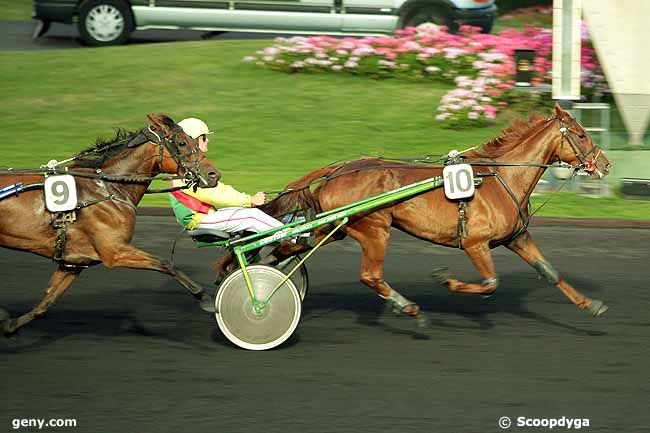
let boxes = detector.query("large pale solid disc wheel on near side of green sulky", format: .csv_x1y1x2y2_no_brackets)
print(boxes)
215,265,301,350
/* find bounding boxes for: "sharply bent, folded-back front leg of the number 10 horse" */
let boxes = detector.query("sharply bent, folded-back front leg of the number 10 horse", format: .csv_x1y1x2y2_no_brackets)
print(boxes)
433,243,499,296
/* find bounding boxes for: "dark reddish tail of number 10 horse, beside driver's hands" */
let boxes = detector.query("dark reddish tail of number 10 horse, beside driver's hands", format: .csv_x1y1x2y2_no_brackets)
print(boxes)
260,166,337,217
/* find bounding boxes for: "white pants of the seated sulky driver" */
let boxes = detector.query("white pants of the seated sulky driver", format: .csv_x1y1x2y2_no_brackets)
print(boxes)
198,207,282,233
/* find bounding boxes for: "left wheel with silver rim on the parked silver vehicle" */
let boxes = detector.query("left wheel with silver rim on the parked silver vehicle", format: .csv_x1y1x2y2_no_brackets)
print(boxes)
77,0,135,47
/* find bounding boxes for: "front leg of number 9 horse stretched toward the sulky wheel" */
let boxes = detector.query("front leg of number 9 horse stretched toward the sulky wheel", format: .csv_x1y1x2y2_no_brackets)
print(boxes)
97,244,215,313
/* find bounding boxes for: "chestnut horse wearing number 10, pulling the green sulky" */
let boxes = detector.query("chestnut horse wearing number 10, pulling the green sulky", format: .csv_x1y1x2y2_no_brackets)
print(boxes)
264,106,610,316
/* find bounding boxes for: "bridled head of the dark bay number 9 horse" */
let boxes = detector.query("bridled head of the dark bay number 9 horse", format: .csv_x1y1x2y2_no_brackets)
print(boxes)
147,114,221,188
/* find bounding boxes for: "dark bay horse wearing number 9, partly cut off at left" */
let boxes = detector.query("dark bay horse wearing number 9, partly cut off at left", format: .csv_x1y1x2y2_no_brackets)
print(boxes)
0,115,220,334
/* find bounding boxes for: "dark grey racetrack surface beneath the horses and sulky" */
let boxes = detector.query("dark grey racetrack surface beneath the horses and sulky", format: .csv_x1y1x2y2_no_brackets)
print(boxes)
0,217,650,433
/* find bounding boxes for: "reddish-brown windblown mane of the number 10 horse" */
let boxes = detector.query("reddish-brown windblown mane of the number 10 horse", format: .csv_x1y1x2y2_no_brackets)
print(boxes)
466,115,547,159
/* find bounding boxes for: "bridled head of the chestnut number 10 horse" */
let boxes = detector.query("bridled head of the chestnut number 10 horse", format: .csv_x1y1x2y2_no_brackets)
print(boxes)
551,104,611,179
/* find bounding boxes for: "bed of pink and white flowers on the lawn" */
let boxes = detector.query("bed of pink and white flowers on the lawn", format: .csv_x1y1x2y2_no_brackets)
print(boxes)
244,16,607,127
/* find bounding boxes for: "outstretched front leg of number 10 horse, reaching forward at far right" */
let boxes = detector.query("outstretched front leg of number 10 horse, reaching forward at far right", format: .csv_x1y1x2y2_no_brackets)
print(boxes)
506,232,608,316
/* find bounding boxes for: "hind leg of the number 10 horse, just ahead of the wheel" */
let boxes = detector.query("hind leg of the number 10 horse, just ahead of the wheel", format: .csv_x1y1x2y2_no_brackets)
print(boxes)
346,221,420,317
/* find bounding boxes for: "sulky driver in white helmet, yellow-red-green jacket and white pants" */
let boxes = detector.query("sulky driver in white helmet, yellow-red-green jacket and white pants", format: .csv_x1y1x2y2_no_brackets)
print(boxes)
169,117,282,234
